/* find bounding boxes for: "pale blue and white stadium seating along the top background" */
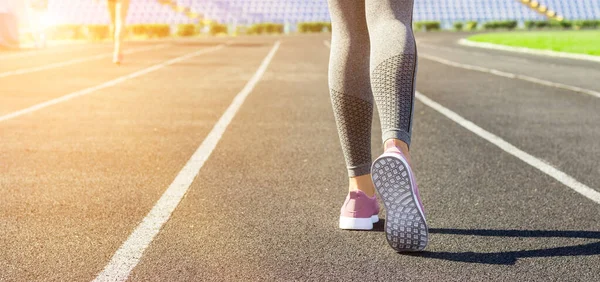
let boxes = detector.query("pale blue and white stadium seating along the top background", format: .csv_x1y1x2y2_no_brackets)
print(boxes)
48,0,600,26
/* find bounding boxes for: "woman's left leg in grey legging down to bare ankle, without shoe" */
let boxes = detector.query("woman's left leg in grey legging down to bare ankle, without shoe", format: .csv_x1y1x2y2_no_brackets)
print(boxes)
329,0,375,196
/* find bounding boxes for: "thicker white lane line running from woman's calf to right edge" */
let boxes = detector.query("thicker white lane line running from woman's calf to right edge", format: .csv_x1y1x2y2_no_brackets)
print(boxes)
416,92,600,204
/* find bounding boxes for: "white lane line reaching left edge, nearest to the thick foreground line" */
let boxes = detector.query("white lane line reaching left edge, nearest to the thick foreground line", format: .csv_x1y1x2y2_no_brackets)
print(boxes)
0,45,224,122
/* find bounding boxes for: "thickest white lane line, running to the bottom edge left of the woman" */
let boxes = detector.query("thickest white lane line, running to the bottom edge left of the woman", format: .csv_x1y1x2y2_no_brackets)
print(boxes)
94,41,280,282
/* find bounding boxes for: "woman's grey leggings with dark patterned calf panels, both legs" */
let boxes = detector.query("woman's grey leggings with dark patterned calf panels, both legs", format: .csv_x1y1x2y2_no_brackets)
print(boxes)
328,0,417,177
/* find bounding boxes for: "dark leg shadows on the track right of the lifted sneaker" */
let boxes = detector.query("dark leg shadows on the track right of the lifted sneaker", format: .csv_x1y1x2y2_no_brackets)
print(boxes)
408,227,600,265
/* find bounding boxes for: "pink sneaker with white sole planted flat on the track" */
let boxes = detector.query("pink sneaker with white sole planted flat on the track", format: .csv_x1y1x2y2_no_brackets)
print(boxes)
340,190,379,230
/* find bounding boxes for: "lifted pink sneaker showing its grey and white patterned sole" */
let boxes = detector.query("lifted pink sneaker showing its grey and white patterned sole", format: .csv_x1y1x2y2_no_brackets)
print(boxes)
371,147,429,252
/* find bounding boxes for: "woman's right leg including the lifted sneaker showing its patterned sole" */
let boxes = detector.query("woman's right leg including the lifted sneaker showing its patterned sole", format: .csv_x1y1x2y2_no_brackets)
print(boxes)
366,0,429,252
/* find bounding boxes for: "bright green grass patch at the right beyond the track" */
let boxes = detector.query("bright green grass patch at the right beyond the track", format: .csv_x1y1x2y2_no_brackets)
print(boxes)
469,30,600,56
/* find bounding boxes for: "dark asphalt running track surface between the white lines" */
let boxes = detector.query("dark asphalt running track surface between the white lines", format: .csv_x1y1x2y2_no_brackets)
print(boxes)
0,33,600,281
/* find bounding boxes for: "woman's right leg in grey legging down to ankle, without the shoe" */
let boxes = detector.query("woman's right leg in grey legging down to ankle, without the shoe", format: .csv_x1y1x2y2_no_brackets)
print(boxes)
366,0,417,159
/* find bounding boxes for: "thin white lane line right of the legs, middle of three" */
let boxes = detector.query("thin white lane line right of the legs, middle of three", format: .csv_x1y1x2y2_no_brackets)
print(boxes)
419,52,600,98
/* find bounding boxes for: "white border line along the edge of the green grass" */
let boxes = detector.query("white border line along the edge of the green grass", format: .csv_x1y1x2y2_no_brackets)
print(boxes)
458,38,600,63
